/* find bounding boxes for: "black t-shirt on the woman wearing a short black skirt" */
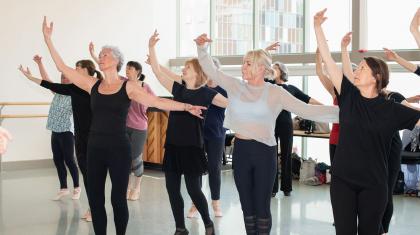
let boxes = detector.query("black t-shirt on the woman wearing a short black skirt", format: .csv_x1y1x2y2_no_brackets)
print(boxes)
165,82,217,148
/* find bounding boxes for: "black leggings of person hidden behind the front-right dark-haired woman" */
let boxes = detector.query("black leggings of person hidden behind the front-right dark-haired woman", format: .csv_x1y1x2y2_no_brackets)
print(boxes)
379,134,402,234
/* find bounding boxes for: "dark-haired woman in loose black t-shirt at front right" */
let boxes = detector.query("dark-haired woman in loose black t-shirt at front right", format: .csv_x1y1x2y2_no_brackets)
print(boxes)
314,9,420,235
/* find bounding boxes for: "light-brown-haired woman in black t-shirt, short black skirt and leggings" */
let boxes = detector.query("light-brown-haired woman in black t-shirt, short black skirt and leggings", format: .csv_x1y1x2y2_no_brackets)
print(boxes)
148,31,227,235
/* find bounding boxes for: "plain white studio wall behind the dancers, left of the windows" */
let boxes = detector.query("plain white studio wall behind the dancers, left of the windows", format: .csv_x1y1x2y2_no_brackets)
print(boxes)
0,0,176,162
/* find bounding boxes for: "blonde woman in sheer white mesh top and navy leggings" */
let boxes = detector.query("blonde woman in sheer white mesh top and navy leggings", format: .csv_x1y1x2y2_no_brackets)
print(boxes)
195,34,338,235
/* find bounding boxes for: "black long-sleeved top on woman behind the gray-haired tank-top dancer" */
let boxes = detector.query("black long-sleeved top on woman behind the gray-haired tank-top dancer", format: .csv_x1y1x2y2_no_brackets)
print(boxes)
40,80,92,137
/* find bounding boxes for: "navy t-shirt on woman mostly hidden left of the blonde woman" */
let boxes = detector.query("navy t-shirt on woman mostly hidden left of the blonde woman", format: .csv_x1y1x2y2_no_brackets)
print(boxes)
204,86,227,139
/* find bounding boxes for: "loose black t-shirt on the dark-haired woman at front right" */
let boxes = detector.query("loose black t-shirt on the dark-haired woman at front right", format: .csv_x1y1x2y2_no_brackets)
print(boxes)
332,77,420,187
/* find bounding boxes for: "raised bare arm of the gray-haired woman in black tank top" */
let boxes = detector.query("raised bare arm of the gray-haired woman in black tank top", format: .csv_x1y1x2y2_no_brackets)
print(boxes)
42,16,97,93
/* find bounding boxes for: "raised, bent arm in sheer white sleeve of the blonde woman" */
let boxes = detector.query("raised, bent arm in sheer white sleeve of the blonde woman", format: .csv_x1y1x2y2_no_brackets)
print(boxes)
194,34,238,93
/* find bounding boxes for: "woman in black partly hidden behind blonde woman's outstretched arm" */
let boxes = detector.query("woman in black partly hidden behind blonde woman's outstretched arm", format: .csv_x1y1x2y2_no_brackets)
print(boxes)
271,61,322,197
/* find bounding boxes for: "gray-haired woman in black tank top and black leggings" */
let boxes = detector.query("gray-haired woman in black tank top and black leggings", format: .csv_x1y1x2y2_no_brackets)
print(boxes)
43,17,205,235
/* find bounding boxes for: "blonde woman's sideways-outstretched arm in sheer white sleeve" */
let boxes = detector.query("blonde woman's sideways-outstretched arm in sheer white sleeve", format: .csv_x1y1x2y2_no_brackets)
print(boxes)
275,87,339,123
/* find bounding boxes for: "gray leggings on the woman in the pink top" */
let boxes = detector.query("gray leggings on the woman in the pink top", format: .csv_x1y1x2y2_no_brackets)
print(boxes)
127,127,147,177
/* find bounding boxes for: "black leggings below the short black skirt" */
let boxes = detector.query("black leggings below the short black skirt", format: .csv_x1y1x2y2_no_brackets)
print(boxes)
165,171,212,228
